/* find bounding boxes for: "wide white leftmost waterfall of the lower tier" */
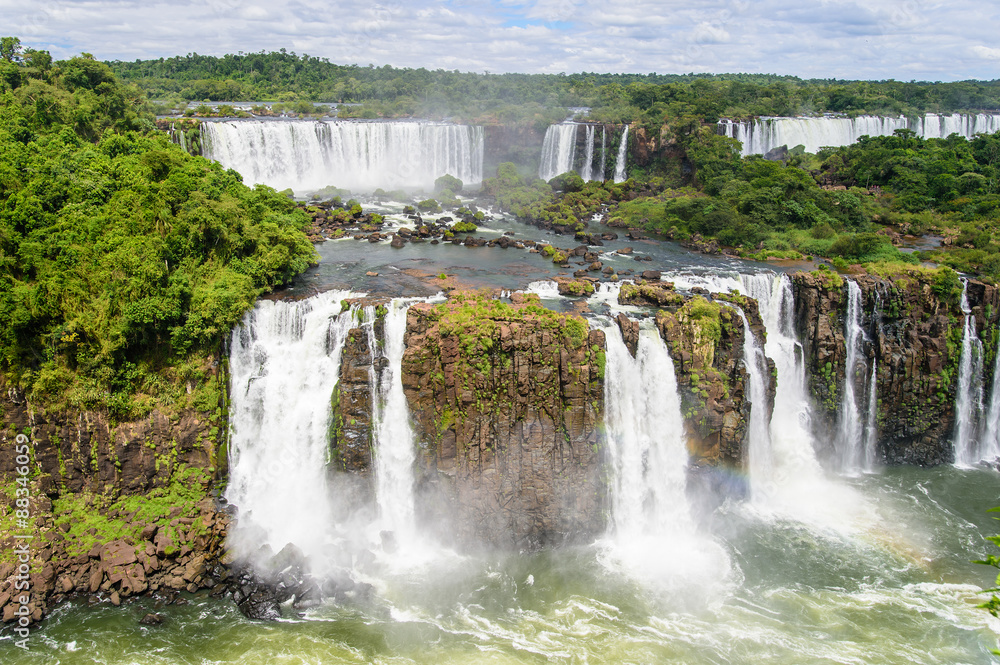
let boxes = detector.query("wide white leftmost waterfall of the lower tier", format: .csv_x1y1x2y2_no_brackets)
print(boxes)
226,291,355,557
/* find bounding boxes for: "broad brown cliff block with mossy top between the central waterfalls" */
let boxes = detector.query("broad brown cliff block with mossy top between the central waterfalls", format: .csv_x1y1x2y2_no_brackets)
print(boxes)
403,296,605,548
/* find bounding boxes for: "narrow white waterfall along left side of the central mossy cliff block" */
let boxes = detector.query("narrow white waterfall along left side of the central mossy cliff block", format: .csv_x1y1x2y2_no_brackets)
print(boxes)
365,299,416,537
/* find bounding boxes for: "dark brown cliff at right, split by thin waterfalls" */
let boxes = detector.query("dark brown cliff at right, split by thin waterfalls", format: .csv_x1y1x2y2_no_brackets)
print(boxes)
792,271,1000,465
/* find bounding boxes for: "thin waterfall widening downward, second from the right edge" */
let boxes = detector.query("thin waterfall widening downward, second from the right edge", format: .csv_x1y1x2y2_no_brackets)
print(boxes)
954,278,983,465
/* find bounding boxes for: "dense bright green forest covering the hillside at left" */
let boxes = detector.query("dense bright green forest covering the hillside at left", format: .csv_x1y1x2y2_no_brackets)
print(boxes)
0,38,315,419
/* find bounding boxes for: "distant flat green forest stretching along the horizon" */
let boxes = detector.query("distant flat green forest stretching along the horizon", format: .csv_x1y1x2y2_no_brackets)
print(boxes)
108,49,1000,123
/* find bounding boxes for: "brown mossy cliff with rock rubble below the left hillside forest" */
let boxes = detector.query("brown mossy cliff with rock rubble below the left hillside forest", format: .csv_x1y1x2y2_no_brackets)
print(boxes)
0,380,228,622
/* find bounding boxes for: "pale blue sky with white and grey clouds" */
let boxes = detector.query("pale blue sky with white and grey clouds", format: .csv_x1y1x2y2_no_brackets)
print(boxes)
0,0,1000,81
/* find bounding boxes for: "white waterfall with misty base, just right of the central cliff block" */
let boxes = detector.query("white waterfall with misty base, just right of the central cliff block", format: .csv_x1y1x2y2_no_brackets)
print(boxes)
601,319,731,600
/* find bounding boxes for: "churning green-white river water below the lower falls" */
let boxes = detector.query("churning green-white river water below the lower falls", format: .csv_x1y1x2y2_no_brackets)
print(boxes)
0,467,1000,665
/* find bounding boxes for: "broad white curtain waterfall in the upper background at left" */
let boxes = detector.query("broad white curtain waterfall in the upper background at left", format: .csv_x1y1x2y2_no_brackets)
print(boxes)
201,120,483,192
